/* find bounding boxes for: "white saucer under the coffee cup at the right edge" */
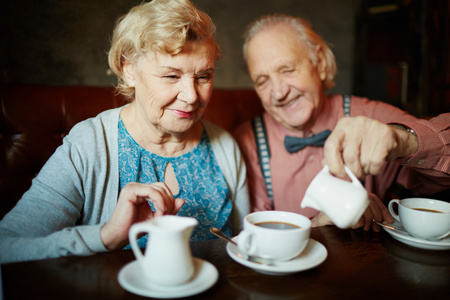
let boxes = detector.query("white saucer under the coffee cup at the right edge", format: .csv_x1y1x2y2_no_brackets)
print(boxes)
379,221,450,250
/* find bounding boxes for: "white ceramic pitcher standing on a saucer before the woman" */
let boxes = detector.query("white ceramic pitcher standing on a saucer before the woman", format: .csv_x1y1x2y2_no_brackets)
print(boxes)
129,216,198,286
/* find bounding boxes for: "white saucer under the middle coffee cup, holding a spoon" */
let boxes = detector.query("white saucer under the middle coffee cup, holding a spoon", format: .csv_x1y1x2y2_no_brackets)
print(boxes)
227,239,328,275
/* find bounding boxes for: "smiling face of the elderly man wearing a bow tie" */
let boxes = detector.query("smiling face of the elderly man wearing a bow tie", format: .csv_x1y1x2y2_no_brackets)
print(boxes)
246,23,326,130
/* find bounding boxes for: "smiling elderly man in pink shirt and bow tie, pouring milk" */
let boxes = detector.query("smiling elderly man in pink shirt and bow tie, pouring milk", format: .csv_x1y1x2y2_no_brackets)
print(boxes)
236,15,450,231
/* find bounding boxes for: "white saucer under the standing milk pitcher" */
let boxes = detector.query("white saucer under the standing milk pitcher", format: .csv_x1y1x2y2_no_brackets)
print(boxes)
118,257,219,298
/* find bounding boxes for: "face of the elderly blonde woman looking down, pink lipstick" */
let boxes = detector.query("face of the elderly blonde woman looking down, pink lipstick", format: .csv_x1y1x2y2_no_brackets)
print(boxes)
124,42,215,134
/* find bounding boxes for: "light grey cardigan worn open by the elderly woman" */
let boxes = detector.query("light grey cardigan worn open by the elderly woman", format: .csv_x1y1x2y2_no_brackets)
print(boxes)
0,108,249,263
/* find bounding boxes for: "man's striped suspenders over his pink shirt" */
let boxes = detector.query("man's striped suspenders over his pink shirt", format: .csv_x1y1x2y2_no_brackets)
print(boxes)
252,95,352,208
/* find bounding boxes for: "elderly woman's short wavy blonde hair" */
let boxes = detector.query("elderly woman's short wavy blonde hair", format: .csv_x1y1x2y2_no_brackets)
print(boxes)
108,0,220,100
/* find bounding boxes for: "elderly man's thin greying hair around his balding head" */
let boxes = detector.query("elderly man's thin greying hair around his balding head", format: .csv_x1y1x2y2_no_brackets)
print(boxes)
243,14,337,89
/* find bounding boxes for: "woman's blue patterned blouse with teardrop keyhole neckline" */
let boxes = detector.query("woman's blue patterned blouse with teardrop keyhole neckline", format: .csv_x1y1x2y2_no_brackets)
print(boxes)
118,119,232,248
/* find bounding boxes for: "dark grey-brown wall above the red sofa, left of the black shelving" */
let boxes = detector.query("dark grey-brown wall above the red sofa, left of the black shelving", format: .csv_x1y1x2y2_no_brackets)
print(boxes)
0,0,359,92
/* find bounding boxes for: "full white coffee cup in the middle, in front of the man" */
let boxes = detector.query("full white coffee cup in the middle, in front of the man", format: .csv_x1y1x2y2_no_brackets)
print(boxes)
236,211,311,261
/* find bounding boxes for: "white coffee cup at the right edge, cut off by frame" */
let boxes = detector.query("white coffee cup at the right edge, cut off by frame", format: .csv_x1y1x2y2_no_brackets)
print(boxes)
388,198,450,240
